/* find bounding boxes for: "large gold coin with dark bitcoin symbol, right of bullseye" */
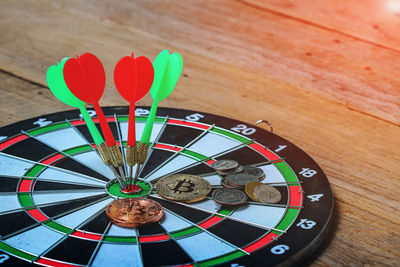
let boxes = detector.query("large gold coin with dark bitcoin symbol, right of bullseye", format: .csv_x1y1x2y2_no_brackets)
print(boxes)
156,174,211,203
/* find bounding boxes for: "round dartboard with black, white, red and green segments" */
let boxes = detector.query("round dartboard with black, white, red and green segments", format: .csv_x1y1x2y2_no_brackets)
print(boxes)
0,107,333,266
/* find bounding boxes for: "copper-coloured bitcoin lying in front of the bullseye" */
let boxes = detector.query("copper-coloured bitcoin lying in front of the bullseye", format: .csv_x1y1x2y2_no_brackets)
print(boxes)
106,197,164,228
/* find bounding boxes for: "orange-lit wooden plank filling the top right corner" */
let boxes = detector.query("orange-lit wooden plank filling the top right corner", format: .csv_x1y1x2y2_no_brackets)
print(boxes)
239,0,400,51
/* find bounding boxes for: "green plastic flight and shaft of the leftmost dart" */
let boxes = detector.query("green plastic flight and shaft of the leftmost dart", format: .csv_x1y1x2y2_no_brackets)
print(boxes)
46,57,104,145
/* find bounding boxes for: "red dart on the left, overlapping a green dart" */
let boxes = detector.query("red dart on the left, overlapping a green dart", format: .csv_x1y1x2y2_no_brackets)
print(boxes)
63,53,126,187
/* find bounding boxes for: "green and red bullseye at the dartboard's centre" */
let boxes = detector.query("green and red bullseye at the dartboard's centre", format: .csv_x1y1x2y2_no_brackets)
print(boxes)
106,178,153,198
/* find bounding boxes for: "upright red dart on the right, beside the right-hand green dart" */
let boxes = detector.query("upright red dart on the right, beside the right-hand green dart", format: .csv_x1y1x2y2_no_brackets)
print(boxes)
114,53,154,191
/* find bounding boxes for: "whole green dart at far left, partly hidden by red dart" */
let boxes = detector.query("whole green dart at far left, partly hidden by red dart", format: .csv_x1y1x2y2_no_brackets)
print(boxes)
46,57,122,189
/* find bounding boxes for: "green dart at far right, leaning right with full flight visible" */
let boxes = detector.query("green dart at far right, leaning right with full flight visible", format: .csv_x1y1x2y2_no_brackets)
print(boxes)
133,50,183,187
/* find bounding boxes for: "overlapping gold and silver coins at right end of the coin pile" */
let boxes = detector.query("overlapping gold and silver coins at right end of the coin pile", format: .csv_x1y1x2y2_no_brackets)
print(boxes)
245,182,282,203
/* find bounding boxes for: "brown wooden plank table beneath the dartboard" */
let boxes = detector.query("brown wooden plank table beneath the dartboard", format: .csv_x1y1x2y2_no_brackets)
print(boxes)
0,0,400,266
